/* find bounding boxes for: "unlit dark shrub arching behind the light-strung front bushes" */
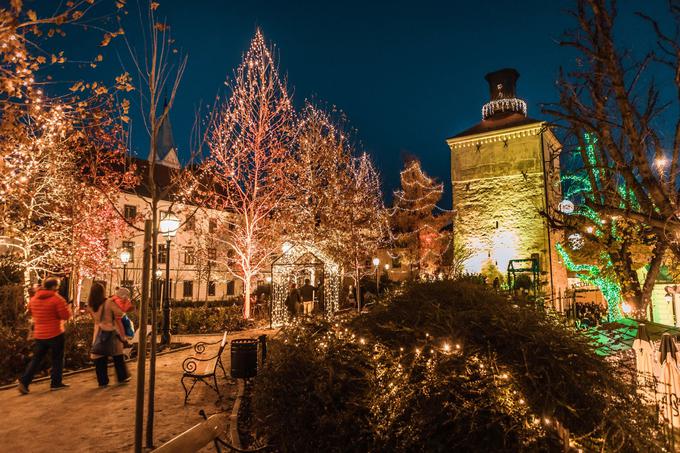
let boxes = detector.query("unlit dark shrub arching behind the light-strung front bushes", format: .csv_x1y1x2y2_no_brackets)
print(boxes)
354,282,659,451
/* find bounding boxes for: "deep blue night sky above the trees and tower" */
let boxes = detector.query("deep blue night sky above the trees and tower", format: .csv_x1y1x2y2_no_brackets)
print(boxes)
47,0,676,207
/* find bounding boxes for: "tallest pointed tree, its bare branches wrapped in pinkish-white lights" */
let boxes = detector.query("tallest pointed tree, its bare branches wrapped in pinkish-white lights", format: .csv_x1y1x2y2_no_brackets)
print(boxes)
205,30,293,318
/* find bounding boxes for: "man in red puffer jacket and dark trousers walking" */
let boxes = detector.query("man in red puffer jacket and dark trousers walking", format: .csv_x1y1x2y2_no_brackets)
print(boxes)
18,278,72,394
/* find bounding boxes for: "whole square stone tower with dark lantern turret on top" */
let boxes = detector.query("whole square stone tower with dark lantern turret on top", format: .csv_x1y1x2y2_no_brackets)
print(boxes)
447,69,567,294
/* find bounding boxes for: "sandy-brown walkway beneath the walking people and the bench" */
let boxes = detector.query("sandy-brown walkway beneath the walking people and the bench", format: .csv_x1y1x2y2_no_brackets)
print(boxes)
0,330,272,453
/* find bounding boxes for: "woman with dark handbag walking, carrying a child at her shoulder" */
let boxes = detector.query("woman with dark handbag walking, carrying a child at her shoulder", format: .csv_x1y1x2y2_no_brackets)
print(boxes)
87,283,131,387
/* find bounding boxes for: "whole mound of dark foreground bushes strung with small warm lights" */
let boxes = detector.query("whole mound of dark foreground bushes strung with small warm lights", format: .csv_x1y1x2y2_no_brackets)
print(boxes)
253,282,660,452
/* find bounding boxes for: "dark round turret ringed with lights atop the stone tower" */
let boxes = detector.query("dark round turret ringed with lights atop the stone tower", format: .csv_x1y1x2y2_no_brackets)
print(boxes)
482,68,527,120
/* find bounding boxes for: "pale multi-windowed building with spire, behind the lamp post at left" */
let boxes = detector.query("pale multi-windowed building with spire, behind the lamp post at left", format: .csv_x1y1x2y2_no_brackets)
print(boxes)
82,115,244,301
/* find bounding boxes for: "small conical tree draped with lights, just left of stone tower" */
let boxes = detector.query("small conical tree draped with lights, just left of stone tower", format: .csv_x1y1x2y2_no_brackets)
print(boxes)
391,159,452,278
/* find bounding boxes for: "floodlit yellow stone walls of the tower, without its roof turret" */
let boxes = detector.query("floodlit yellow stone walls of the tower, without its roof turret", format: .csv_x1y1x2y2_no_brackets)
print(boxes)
450,126,566,291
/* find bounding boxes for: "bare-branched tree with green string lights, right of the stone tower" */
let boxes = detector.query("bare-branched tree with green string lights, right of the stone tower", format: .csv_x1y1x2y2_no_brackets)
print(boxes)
544,0,680,316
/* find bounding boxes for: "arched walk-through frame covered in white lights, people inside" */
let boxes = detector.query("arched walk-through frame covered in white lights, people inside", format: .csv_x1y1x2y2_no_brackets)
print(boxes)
272,243,342,325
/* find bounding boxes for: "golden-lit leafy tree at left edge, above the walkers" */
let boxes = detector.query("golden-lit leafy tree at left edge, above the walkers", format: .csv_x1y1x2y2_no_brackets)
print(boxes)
0,2,134,296
